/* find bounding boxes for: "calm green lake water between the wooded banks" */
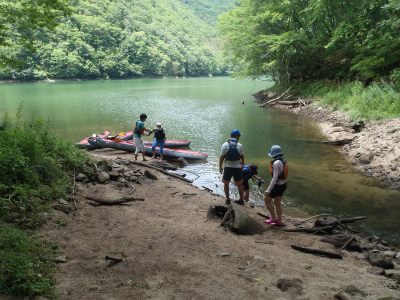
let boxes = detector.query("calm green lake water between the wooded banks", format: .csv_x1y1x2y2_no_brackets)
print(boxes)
0,78,400,245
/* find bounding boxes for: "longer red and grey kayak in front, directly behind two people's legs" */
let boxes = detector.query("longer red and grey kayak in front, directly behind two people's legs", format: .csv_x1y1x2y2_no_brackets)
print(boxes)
89,138,208,160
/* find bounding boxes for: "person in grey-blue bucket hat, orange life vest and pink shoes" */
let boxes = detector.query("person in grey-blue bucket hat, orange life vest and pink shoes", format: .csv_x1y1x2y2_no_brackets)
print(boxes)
264,145,289,226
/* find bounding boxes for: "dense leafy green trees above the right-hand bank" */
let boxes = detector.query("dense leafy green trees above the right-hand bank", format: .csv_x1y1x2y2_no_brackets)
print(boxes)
220,0,400,84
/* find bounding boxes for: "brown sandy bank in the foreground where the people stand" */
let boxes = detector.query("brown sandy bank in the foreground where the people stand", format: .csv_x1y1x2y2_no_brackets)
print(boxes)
32,149,400,300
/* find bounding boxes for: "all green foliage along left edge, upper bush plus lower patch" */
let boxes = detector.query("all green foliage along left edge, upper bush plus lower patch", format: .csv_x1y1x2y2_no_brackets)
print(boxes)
0,109,90,298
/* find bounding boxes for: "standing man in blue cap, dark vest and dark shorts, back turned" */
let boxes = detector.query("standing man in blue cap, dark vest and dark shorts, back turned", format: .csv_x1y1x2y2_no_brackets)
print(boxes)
219,129,244,205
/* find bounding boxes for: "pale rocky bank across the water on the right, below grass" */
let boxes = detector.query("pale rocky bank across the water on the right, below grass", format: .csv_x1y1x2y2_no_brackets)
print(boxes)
253,91,400,187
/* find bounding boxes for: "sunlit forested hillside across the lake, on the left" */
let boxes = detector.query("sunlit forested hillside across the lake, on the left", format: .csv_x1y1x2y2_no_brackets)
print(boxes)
0,0,234,80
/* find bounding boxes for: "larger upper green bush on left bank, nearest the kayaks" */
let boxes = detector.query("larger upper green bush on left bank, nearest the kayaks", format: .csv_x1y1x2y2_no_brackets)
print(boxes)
0,108,89,226
